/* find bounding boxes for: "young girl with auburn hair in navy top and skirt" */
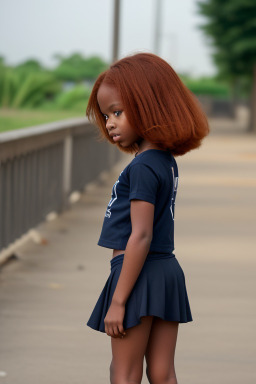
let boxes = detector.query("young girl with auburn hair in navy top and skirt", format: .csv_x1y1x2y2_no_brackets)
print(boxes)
86,53,209,384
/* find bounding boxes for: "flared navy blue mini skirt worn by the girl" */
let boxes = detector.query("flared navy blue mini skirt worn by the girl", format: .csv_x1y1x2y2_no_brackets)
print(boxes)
87,253,193,332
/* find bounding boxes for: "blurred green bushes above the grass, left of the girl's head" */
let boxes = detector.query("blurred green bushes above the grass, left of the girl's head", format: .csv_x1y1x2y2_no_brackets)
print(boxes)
0,53,107,111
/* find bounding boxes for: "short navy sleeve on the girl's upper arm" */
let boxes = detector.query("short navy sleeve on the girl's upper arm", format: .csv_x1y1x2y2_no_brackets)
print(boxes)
129,163,159,204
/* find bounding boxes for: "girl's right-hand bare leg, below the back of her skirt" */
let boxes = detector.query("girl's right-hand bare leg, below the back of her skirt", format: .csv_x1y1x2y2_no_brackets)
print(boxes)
145,317,179,384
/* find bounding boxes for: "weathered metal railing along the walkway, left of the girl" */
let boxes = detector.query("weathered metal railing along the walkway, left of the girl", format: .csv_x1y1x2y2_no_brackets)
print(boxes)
0,118,122,251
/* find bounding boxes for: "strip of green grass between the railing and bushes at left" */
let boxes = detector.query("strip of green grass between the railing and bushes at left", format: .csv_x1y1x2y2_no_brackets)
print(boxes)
0,108,85,132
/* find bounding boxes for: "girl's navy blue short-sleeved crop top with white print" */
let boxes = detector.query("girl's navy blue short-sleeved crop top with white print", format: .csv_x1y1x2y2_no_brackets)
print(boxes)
98,149,178,253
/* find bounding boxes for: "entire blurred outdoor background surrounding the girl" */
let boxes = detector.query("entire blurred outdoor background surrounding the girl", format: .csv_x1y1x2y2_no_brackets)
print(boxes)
0,0,256,384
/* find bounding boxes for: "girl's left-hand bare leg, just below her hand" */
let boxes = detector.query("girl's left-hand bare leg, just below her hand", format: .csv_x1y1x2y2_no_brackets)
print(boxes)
110,316,153,384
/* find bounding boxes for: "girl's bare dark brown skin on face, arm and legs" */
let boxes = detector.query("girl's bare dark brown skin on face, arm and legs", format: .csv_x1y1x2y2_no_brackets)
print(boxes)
97,84,179,384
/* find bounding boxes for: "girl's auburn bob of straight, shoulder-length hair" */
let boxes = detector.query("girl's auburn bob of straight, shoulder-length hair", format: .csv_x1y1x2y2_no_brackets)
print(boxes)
86,53,209,156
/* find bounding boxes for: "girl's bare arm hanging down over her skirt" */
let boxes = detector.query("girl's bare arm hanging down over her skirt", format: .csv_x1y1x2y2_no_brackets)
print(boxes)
104,200,155,337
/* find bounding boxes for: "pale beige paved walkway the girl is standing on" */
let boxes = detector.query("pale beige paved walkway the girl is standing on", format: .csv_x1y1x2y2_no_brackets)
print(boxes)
0,118,256,384
